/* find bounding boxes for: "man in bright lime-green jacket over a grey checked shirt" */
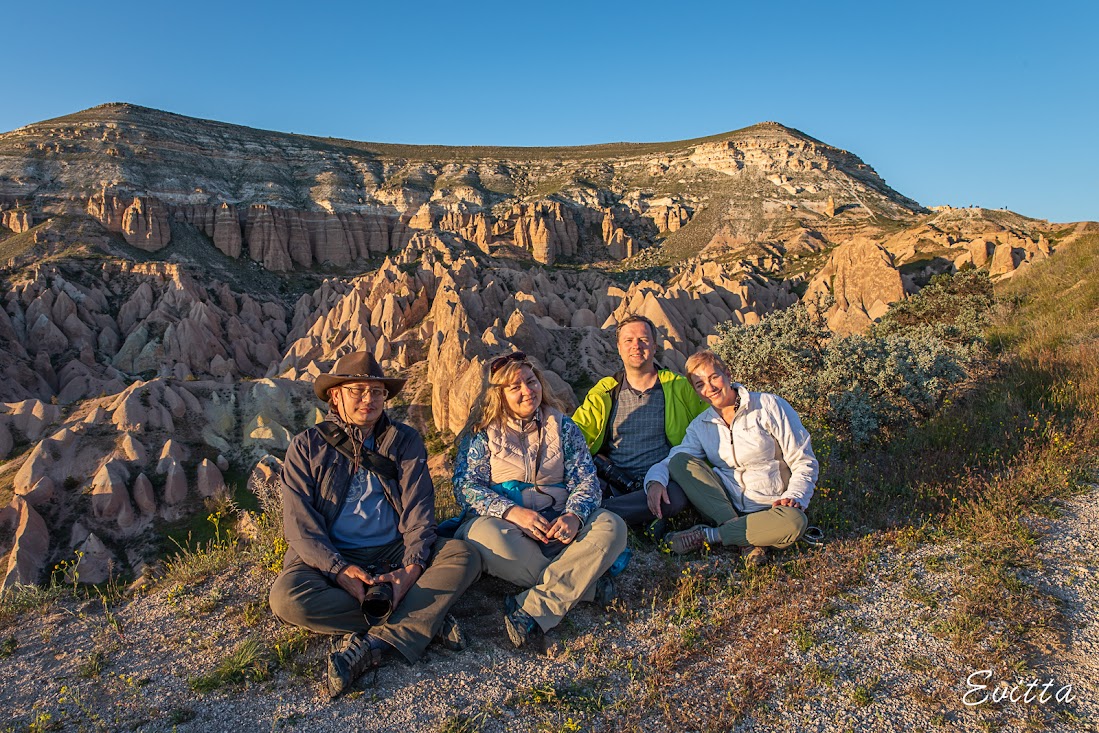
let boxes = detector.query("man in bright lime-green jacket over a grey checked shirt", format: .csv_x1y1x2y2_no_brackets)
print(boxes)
573,315,707,535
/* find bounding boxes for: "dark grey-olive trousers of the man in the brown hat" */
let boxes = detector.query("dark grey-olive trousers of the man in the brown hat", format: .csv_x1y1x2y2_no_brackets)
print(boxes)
270,537,481,662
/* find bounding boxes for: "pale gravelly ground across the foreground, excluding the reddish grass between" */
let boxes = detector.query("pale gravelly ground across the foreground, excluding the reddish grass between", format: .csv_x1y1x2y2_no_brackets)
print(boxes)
0,488,1099,733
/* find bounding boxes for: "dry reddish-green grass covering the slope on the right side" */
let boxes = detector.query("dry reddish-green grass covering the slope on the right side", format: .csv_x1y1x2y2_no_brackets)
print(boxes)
571,237,1099,730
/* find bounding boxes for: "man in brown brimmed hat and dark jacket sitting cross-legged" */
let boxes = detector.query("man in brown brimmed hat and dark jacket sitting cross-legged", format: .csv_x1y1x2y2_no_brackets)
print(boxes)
270,352,480,698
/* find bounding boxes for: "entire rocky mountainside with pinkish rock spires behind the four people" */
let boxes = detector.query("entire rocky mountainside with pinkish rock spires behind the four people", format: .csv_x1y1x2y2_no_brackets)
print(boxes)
0,104,1089,586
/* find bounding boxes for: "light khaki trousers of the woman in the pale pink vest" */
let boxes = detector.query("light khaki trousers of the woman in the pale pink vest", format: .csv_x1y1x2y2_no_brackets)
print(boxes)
457,509,626,631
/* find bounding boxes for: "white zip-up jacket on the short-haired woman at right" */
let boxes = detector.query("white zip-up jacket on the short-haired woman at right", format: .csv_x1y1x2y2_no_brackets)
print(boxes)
645,385,819,512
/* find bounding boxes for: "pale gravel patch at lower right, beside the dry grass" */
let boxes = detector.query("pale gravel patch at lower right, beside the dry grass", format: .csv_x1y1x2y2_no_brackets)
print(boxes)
741,487,1099,732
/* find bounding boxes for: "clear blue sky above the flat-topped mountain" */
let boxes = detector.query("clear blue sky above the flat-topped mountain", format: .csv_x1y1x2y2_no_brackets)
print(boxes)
0,0,1099,221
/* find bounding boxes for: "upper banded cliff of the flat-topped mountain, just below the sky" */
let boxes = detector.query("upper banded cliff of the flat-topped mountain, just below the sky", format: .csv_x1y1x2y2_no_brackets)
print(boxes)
0,104,921,271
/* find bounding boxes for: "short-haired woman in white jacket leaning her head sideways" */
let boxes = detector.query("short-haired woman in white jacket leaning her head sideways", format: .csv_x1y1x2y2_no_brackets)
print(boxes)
645,351,818,565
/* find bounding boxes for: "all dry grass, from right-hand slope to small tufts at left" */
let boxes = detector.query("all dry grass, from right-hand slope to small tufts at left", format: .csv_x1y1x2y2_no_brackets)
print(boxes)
0,236,1099,731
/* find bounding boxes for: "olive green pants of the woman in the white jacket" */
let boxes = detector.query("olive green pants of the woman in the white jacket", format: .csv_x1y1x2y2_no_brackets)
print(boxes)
668,453,809,548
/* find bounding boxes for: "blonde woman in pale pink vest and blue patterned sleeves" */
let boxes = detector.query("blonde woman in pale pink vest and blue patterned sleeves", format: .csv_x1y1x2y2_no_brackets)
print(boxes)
454,352,626,646
